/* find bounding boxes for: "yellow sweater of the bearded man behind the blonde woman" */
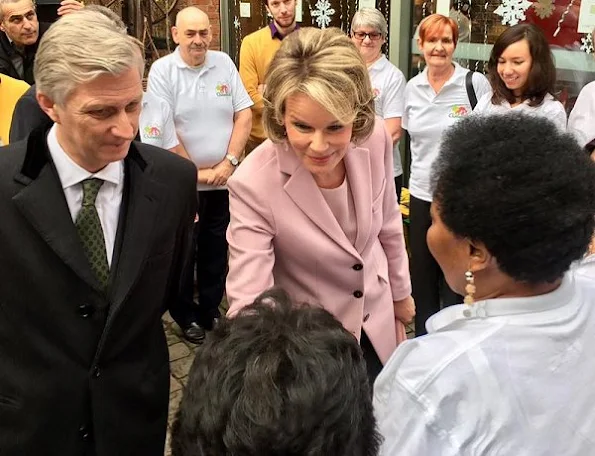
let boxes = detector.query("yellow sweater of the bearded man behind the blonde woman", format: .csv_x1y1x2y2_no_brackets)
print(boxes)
240,26,281,140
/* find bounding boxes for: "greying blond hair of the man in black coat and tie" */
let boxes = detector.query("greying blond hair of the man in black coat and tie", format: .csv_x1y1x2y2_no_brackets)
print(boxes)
33,8,144,105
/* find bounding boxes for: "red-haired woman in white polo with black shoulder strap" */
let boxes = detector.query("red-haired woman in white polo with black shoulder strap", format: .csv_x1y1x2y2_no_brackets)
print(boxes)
402,14,490,336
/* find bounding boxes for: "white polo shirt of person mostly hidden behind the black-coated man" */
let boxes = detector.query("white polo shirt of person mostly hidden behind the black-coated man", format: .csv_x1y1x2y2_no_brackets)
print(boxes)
138,93,179,149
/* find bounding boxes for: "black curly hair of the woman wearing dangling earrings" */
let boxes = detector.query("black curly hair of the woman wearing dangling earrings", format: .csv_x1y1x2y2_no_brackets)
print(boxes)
432,113,595,284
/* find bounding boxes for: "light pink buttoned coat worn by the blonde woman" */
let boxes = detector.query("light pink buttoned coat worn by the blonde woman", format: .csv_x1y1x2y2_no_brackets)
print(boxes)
227,119,411,363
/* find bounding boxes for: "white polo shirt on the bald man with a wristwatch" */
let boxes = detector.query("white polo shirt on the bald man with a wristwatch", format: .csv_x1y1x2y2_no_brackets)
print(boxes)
148,48,253,190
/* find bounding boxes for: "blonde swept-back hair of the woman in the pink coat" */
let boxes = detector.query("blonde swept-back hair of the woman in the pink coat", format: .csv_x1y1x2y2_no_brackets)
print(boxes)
262,27,375,143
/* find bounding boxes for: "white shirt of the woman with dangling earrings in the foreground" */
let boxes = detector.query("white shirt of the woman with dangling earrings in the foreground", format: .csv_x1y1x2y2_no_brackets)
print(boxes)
374,271,595,456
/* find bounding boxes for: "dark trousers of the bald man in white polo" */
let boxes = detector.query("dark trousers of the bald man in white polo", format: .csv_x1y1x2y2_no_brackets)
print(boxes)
184,190,229,329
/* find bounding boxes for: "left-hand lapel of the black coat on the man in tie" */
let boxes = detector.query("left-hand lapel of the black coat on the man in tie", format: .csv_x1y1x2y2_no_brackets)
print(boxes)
13,127,101,291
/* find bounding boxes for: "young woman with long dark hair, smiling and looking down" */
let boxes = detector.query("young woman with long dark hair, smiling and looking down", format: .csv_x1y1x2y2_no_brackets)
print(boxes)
473,24,566,131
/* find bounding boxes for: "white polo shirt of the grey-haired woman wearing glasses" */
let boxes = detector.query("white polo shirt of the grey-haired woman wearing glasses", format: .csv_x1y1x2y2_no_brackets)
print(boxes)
368,54,407,177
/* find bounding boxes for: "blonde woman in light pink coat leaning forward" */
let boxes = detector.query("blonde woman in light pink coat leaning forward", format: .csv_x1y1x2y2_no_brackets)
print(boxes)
227,28,415,378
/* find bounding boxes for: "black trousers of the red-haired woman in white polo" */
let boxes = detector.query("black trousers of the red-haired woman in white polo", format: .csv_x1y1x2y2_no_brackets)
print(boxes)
409,196,463,336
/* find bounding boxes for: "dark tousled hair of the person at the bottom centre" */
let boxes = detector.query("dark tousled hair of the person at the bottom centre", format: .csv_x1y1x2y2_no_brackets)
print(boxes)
172,289,380,456
